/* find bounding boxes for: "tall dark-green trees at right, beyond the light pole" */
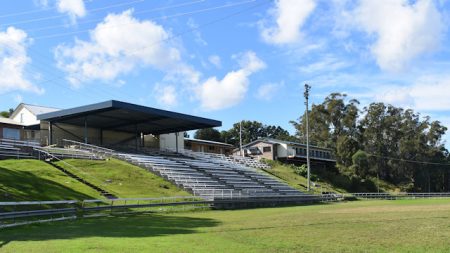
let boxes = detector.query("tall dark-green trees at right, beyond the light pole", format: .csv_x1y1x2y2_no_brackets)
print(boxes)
291,93,450,191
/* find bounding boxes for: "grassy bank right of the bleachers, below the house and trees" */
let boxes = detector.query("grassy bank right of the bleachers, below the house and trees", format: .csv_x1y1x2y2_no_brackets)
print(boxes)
264,160,398,193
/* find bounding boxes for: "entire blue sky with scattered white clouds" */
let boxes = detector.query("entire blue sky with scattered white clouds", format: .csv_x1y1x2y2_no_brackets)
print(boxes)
0,0,450,142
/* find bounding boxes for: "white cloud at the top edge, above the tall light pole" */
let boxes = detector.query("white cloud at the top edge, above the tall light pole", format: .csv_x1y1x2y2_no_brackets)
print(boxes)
260,0,316,44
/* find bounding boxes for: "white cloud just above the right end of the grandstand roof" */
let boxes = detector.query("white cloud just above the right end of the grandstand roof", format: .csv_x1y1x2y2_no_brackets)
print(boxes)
198,51,266,110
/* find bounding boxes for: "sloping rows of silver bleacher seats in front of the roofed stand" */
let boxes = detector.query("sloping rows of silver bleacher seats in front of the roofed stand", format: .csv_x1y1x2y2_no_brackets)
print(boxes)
59,141,303,199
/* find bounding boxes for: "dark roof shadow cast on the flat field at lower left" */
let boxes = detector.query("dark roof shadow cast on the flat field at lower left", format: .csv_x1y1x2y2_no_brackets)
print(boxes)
0,214,220,245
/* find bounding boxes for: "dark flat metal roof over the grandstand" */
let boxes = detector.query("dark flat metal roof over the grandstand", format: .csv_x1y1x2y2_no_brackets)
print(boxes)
37,100,222,134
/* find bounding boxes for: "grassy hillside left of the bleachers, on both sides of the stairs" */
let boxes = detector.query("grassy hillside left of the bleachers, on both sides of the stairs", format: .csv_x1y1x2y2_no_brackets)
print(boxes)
0,159,189,201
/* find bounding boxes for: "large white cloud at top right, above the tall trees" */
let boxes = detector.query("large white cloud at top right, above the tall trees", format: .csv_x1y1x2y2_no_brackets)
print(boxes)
351,0,444,71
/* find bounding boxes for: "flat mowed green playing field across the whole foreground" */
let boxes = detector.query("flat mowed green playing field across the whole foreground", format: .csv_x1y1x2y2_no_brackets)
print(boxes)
0,199,450,252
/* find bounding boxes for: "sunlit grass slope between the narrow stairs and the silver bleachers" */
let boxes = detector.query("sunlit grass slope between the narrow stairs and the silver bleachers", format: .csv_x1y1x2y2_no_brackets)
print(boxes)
57,159,189,198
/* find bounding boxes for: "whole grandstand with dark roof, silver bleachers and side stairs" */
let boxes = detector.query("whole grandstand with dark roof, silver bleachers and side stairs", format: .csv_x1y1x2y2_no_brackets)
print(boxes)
0,100,302,199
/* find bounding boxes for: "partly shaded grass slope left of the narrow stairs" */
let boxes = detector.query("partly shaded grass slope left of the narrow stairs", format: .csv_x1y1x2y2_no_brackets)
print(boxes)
0,159,100,201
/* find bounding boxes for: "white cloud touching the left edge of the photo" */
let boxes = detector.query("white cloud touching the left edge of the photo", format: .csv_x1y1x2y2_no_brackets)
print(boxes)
0,27,44,94
